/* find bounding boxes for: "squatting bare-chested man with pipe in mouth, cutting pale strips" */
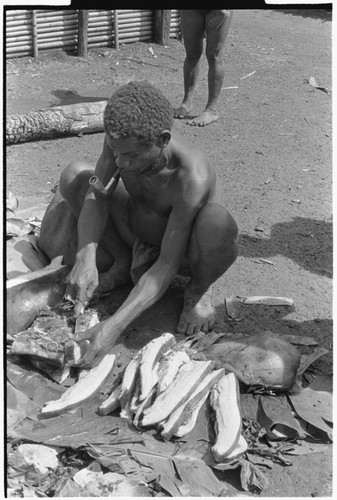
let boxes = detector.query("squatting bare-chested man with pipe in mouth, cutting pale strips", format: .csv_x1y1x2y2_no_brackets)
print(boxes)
40,81,238,366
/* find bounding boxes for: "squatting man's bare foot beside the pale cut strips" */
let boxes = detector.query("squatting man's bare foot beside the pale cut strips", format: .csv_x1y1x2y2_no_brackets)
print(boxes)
177,291,215,335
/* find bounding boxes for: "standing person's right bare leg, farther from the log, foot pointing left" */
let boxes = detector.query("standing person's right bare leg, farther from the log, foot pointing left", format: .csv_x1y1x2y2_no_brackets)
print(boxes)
190,11,232,127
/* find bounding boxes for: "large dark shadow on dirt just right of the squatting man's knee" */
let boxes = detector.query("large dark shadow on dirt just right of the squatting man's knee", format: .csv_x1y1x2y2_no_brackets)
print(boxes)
239,217,333,278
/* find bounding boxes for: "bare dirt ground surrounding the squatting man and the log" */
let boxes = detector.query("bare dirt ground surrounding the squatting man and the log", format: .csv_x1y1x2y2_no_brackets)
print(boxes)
5,9,333,497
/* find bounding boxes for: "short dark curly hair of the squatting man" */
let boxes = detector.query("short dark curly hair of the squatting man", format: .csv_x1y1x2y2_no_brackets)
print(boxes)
104,81,173,145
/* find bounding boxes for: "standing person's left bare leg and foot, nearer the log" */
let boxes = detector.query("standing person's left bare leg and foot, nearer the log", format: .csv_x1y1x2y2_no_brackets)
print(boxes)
174,10,205,118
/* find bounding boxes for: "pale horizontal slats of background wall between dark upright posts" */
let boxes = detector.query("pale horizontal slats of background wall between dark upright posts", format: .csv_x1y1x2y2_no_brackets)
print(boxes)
5,9,180,58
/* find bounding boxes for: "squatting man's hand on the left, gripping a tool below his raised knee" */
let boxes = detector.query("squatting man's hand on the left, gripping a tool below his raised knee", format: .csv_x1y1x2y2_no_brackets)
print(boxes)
66,250,98,318
